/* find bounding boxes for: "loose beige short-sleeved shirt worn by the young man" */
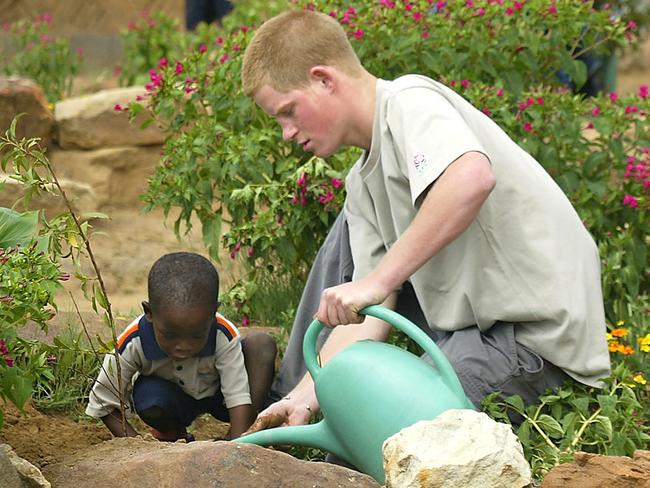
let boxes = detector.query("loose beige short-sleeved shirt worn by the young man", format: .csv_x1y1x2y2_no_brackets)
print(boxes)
346,75,610,385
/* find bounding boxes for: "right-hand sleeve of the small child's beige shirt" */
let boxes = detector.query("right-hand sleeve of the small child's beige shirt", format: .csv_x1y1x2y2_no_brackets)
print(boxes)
215,332,252,408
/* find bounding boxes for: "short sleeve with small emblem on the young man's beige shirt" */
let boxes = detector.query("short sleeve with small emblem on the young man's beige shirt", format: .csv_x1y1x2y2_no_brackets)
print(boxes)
386,87,486,206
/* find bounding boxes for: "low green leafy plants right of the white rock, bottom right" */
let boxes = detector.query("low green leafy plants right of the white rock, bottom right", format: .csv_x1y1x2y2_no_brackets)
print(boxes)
483,365,650,478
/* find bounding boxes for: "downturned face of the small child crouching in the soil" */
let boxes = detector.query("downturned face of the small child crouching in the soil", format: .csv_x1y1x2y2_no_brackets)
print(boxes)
142,302,214,361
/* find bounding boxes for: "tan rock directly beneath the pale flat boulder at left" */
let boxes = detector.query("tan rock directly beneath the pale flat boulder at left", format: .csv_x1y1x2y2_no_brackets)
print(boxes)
48,146,161,208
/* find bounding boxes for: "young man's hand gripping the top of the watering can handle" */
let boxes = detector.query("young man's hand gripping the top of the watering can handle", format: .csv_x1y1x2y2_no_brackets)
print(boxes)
316,275,393,327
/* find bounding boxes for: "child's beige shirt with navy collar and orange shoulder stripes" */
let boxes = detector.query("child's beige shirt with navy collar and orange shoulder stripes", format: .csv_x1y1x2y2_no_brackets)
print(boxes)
86,313,251,418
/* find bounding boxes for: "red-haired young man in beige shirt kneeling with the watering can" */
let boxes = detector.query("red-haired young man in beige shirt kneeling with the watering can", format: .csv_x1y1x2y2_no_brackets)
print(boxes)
242,11,609,430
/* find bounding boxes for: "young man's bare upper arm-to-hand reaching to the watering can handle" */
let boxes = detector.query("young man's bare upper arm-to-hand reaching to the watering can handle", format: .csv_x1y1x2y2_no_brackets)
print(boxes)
317,152,496,327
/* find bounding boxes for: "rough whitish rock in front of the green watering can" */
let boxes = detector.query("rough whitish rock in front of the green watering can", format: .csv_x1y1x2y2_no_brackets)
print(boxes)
383,410,531,488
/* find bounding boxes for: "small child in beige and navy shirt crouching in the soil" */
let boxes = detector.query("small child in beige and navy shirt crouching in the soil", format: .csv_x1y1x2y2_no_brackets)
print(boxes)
86,252,276,441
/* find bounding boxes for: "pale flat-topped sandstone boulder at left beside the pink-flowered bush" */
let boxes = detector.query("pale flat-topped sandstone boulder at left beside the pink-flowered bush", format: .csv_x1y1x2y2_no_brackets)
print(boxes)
54,86,164,149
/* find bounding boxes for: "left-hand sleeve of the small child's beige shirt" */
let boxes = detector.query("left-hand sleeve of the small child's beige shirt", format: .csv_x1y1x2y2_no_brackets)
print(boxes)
86,342,139,418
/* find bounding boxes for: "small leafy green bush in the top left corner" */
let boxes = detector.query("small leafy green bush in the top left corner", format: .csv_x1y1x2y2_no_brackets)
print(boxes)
1,14,81,103
